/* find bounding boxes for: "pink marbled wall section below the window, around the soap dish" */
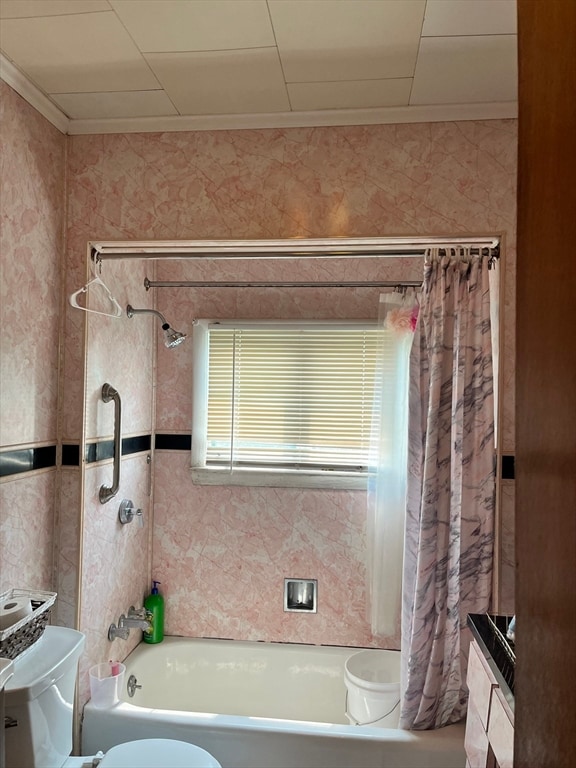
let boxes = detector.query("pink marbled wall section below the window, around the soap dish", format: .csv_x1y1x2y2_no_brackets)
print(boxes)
154,452,374,646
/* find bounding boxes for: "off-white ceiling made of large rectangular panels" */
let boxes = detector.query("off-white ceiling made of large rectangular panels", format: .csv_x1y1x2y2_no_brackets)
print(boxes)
0,0,517,133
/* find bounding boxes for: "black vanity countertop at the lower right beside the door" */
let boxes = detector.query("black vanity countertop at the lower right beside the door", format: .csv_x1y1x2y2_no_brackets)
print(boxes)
468,613,516,711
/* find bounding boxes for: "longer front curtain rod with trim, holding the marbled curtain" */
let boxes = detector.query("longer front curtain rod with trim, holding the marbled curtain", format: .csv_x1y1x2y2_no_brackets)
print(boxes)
89,237,500,263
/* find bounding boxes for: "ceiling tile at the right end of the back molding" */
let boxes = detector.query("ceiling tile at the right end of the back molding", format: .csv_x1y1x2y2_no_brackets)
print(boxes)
410,35,518,105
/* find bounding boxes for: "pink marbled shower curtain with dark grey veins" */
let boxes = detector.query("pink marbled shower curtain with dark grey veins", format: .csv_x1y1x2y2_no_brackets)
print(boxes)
400,254,495,729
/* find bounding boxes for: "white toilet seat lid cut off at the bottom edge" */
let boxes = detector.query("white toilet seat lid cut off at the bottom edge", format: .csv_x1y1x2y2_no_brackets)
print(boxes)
99,739,222,768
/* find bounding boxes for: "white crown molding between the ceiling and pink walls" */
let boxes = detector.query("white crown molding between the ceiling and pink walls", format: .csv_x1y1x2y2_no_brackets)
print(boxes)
0,53,518,136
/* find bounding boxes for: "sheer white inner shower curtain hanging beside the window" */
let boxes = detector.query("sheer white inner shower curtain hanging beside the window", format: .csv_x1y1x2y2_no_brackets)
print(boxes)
367,288,418,636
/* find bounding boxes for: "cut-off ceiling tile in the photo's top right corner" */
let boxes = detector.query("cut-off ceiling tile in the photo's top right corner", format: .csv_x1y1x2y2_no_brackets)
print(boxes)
422,0,516,37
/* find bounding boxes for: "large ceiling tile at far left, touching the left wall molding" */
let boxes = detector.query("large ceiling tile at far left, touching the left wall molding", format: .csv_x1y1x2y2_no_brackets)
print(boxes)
0,11,158,93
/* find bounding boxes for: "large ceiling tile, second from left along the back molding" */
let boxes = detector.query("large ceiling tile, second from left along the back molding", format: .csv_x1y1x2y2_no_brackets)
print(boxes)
146,48,290,115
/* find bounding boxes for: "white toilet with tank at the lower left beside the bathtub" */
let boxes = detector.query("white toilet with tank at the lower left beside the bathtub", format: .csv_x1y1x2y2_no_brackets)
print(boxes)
4,627,221,768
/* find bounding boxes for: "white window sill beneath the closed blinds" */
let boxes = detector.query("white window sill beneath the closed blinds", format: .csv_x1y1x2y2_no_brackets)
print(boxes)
191,467,368,491
